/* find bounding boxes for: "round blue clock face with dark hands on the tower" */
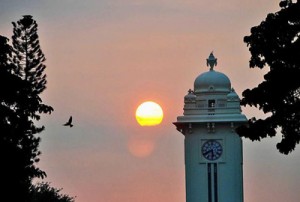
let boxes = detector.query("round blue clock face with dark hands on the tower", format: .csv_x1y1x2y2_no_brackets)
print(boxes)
202,140,223,161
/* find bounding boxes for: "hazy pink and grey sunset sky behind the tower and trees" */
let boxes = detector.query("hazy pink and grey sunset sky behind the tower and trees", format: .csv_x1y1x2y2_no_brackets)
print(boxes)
0,0,300,202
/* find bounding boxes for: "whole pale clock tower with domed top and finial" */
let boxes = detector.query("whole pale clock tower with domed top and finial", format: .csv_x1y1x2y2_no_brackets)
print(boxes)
174,53,247,202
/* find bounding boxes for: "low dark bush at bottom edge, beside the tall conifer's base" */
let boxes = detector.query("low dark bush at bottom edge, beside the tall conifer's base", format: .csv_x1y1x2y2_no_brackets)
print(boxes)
31,182,75,202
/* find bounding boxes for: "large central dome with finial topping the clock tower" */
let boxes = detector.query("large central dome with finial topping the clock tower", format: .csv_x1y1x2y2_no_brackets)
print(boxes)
194,53,231,94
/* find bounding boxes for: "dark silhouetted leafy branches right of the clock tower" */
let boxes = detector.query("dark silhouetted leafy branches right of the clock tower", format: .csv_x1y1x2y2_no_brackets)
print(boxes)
237,0,300,154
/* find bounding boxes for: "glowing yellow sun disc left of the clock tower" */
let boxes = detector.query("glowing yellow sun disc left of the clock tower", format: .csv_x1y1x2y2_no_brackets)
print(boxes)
135,101,163,126
